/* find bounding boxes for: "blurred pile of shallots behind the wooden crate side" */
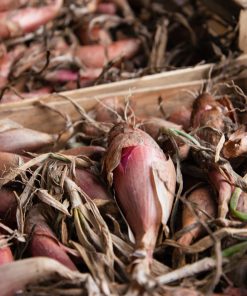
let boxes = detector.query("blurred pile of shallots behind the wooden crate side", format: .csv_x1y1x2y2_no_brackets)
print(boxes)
0,0,240,103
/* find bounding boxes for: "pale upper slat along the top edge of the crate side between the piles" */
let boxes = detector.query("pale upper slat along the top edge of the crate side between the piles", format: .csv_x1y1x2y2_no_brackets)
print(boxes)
0,55,247,113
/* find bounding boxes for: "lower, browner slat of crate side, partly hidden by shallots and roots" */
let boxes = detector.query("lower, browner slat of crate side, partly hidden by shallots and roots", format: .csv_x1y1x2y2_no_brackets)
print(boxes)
0,81,202,133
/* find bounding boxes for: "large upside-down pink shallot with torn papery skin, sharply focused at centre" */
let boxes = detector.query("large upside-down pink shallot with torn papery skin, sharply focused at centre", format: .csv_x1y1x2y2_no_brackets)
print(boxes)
104,123,176,256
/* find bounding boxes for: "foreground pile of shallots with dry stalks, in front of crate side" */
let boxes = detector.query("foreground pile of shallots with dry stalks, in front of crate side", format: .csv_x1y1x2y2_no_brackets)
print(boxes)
0,85,247,296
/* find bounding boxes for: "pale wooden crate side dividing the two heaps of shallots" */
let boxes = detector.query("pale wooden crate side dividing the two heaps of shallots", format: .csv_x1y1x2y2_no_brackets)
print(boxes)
0,55,247,133
